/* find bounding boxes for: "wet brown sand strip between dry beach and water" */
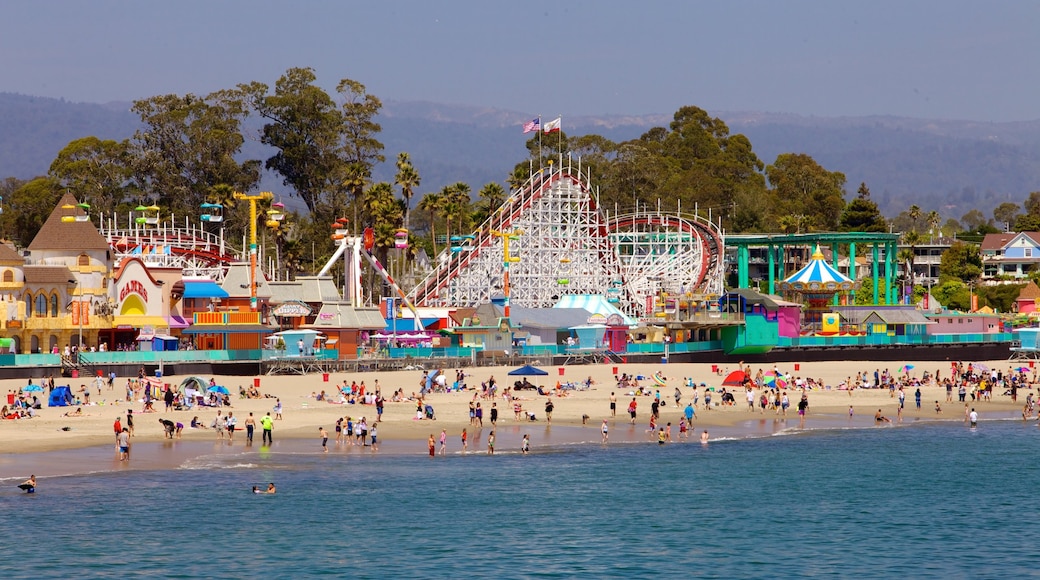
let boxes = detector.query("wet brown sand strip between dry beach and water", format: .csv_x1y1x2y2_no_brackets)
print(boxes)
0,410,1027,481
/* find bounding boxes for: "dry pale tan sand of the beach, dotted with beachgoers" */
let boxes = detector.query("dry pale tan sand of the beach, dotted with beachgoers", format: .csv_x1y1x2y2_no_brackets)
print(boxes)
0,361,1035,461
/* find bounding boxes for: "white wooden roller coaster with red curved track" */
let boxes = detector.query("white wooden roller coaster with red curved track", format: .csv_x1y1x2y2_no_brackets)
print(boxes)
409,160,725,317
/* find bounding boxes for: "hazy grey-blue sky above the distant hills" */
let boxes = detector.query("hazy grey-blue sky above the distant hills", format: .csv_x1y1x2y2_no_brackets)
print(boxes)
0,0,1040,122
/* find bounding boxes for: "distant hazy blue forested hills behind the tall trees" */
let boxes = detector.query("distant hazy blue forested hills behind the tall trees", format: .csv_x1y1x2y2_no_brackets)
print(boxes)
0,94,1040,218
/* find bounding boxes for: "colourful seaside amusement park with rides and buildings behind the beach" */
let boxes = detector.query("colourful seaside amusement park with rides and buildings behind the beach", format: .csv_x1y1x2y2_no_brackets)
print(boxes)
0,157,1015,375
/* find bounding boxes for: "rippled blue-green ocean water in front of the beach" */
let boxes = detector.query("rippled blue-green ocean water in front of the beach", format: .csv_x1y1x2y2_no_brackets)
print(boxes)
0,420,1040,578
